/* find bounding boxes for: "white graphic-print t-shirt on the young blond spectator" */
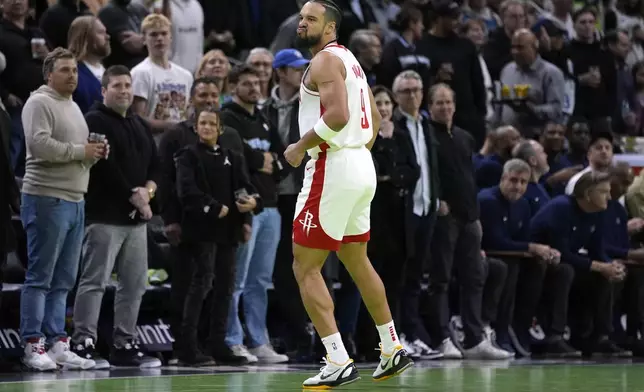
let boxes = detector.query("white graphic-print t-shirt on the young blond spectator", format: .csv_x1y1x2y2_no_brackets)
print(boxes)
132,57,192,122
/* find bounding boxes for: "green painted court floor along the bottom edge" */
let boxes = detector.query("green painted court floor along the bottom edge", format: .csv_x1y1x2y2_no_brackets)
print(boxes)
0,361,644,392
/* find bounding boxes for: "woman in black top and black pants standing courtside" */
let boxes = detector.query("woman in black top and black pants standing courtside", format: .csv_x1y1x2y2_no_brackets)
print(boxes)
175,108,259,366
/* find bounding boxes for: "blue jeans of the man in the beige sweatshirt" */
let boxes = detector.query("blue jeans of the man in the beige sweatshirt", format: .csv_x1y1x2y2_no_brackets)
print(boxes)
20,194,85,341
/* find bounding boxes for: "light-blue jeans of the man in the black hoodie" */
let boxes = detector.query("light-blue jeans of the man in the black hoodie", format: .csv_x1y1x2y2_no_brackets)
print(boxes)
226,208,282,347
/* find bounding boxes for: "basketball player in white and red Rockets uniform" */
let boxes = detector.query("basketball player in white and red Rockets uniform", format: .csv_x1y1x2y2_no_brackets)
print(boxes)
284,0,413,389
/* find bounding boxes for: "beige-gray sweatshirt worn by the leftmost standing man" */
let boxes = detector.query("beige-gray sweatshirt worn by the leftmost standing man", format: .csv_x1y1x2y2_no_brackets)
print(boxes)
22,86,95,202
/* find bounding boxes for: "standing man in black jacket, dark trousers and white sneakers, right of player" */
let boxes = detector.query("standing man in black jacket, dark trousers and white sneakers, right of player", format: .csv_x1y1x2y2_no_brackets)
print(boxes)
429,83,512,359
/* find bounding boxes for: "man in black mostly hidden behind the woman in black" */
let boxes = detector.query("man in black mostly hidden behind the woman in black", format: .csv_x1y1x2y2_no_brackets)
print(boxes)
159,78,246,365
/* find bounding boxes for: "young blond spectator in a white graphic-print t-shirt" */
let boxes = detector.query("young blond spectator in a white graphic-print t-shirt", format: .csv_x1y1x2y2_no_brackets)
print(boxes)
132,14,193,137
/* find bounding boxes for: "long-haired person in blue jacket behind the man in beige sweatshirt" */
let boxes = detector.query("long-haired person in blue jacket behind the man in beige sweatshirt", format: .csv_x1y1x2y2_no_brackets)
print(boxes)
69,16,111,113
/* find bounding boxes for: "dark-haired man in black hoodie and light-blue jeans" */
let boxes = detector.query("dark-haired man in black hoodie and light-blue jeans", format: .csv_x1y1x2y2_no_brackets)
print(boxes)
221,65,288,363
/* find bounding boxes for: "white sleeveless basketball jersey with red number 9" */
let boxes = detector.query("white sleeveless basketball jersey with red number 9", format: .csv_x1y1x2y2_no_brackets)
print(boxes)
299,44,373,156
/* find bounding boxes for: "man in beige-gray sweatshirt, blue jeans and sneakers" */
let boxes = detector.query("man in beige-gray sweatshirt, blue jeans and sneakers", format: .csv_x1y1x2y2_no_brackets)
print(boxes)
20,48,109,371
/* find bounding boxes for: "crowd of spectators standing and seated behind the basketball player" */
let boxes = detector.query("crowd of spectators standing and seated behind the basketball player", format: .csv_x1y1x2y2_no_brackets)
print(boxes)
0,0,644,371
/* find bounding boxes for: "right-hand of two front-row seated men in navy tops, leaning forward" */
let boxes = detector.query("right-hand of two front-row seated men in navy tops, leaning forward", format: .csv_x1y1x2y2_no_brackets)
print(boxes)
530,171,630,356
